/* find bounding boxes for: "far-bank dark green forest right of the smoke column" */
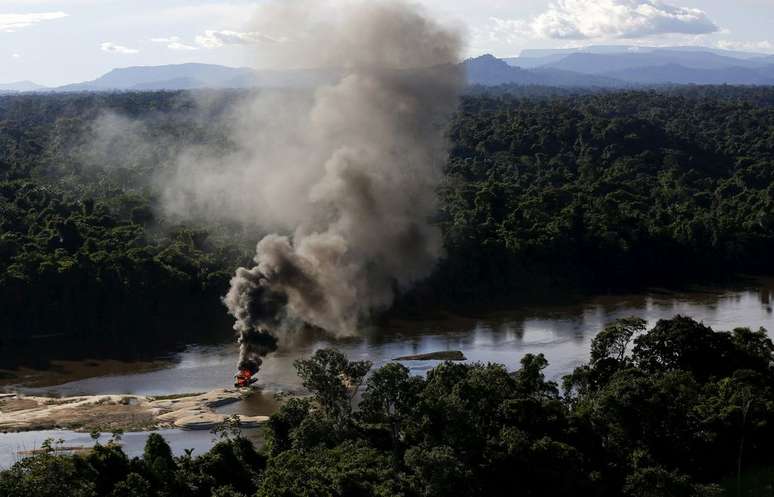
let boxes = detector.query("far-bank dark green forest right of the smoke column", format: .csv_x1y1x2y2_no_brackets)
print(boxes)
433,88,774,301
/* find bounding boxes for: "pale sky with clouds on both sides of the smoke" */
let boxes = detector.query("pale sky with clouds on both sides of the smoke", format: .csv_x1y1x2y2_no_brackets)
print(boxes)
0,0,774,86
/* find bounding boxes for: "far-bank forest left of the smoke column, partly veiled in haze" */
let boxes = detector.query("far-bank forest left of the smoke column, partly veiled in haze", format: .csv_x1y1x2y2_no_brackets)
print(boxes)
0,93,252,343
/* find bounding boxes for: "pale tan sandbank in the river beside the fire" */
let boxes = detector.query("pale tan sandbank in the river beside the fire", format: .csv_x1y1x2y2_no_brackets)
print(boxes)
0,389,269,432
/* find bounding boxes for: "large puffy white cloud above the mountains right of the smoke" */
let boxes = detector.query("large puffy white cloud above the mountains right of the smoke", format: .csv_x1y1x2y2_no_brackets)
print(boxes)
530,0,720,40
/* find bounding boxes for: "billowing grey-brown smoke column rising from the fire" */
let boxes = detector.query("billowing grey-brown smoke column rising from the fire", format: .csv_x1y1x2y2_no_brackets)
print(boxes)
206,0,463,379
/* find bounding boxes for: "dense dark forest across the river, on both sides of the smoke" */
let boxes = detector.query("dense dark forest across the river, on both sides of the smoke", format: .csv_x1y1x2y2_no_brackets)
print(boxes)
0,87,774,344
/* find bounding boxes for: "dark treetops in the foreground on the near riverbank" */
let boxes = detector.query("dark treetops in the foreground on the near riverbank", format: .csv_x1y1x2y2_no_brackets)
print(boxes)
0,316,774,497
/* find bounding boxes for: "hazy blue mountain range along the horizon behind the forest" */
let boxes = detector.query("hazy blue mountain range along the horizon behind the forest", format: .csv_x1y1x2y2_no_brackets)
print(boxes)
0,46,774,93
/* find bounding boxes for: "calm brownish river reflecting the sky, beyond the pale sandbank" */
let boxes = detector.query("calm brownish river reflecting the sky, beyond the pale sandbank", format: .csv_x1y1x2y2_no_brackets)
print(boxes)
9,280,774,395
